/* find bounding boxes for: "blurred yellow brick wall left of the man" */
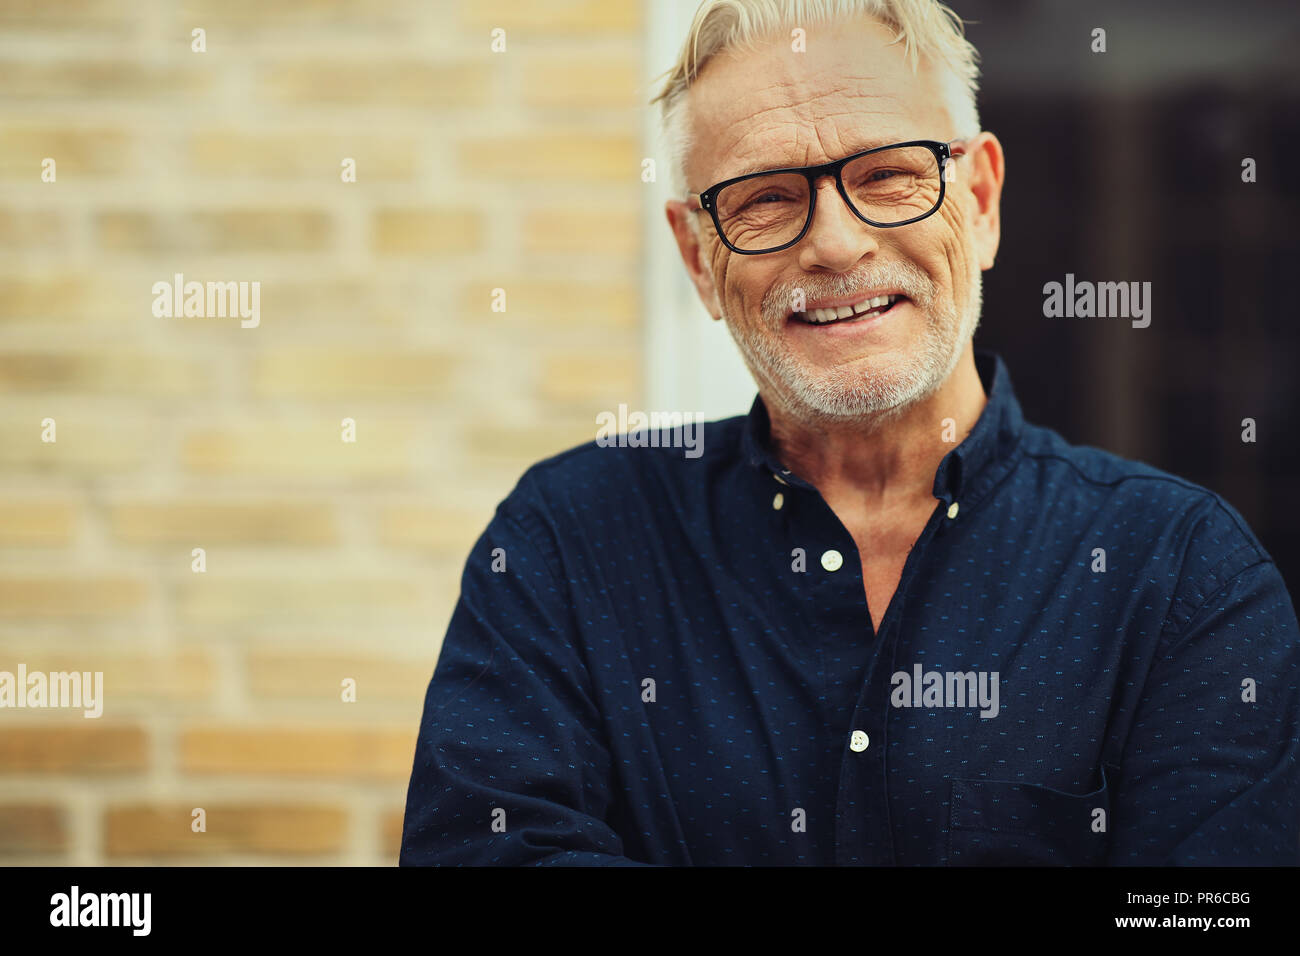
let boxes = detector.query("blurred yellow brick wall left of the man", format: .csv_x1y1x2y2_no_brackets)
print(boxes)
0,0,651,865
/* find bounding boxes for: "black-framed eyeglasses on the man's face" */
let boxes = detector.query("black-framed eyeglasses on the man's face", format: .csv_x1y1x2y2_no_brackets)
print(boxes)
690,139,966,255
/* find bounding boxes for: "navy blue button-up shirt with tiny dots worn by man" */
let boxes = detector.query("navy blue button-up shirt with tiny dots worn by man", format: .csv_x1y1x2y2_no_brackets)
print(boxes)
400,352,1300,865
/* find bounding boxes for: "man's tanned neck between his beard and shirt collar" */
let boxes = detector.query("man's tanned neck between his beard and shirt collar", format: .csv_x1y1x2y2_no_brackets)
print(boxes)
764,342,988,510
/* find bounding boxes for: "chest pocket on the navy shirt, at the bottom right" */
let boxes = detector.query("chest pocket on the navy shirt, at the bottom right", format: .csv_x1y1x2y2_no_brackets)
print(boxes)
948,766,1115,866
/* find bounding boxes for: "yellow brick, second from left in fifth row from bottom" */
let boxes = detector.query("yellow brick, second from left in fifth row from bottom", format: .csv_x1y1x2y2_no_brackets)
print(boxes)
107,499,338,548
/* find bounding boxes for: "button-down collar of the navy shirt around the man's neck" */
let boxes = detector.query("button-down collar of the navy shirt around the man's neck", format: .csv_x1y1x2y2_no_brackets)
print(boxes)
741,349,1024,505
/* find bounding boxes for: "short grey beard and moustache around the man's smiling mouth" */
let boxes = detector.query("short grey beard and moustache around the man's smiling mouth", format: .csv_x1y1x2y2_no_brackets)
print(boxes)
722,250,983,423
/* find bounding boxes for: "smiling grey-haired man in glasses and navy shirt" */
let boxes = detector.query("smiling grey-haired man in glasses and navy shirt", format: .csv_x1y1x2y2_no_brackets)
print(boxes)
400,0,1300,865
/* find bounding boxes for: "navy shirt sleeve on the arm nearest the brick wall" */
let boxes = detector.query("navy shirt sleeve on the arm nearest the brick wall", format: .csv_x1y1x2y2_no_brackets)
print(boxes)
399,486,655,866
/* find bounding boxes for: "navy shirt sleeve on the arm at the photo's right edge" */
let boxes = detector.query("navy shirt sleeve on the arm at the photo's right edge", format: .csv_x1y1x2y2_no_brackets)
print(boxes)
1109,530,1300,866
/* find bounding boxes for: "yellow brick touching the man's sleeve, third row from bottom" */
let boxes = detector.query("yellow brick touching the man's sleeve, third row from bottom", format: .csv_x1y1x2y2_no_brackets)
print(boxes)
248,646,434,708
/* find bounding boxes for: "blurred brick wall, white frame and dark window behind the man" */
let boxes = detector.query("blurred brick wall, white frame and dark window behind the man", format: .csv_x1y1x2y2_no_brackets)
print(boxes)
0,0,1300,865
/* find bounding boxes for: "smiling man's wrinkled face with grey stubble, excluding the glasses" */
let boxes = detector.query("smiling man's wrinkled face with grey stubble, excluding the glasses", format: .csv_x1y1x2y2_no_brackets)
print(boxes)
670,20,1002,420
